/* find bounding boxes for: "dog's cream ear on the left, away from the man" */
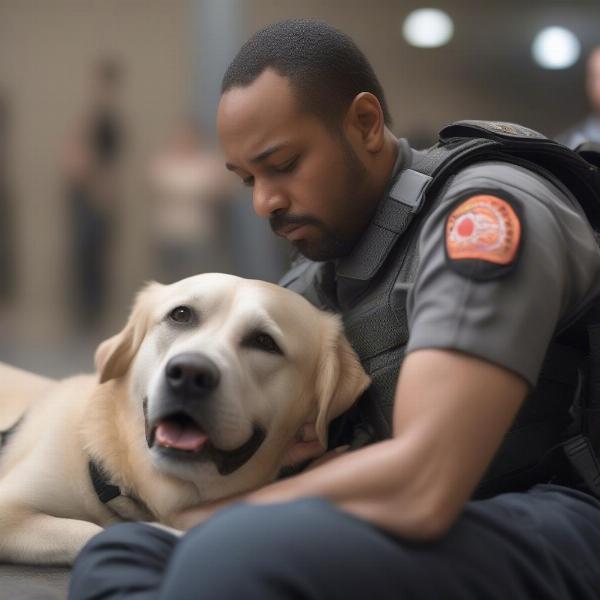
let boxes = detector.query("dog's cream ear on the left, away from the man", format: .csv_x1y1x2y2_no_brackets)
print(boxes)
94,282,163,383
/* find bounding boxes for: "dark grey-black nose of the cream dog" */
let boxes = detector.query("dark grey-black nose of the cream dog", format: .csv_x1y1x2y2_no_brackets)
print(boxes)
165,352,221,398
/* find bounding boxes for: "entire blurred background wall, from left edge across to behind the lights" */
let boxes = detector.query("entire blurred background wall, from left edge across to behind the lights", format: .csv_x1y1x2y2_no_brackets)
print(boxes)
0,0,600,375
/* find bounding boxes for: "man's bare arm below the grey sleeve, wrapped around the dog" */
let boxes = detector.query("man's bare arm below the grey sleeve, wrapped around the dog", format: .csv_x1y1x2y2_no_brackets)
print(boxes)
172,350,527,539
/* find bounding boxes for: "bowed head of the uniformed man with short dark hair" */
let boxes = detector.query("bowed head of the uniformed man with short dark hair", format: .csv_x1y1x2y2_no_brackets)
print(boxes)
218,21,397,260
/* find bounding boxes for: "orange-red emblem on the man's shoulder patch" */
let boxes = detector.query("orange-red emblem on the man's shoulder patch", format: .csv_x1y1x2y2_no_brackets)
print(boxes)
446,194,521,265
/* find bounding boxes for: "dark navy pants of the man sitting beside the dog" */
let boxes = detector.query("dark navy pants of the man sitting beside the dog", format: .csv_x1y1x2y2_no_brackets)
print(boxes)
69,486,600,600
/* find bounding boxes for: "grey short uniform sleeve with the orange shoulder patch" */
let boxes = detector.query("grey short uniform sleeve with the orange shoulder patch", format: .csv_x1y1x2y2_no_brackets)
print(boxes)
407,163,600,386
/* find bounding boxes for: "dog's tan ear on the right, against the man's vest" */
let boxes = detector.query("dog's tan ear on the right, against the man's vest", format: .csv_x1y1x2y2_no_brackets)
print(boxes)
315,315,371,447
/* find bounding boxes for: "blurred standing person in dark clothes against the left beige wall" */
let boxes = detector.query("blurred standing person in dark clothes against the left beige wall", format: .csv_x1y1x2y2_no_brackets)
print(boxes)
64,58,124,328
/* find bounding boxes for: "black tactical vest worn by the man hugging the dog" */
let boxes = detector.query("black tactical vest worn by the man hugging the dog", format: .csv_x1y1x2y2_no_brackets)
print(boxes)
281,121,600,497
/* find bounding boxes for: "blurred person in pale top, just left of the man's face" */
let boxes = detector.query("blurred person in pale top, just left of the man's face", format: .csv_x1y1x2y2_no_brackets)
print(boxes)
150,118,235,283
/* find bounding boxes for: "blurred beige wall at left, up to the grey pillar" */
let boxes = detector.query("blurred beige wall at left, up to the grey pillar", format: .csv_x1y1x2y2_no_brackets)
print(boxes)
0,0,191,372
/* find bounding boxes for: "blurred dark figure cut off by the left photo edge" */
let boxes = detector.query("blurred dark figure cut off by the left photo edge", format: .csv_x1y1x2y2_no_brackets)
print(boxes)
0,90,16,307
